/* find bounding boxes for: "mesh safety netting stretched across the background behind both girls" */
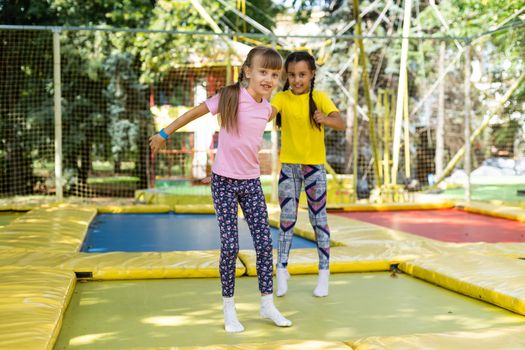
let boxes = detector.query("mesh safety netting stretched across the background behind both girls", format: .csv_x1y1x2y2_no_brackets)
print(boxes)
0,24,525,203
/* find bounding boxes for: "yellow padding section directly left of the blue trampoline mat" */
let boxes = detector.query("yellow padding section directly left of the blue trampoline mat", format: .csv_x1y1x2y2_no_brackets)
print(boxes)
0,204,97,252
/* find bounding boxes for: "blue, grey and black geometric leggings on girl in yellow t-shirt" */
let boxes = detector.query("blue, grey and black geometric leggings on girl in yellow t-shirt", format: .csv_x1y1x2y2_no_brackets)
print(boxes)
277,164,330,270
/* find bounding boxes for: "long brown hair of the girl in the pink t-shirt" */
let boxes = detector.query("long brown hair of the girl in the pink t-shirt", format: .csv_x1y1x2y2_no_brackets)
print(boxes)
218,46,283,134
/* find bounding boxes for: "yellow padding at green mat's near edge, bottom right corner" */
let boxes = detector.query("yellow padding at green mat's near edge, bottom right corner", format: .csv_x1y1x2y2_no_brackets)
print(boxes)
348,326,525,350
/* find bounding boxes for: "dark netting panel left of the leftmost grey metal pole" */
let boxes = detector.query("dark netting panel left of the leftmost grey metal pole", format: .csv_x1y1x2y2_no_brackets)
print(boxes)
0,30,54,196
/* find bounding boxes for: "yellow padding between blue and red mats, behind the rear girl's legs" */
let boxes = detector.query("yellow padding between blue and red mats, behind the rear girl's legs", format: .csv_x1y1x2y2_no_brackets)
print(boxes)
269,210,435,246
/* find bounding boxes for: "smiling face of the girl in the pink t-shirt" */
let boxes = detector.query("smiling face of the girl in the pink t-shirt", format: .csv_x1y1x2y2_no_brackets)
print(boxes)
245,57,281,100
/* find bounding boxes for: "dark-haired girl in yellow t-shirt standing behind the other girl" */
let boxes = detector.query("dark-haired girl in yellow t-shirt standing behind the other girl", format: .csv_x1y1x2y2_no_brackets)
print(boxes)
271,51,346,297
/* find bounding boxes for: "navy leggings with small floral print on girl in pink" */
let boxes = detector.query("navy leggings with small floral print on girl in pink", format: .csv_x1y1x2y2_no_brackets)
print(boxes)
211,174,273,297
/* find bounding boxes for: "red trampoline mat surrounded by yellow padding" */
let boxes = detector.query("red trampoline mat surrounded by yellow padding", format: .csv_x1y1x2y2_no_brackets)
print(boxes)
335,209,525,243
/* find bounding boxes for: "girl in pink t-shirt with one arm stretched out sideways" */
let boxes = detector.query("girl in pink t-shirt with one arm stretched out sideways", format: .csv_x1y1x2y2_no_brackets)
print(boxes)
150,46,292,332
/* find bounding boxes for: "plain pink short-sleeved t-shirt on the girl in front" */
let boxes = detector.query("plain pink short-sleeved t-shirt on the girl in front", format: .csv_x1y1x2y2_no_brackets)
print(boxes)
205,88,272,180
